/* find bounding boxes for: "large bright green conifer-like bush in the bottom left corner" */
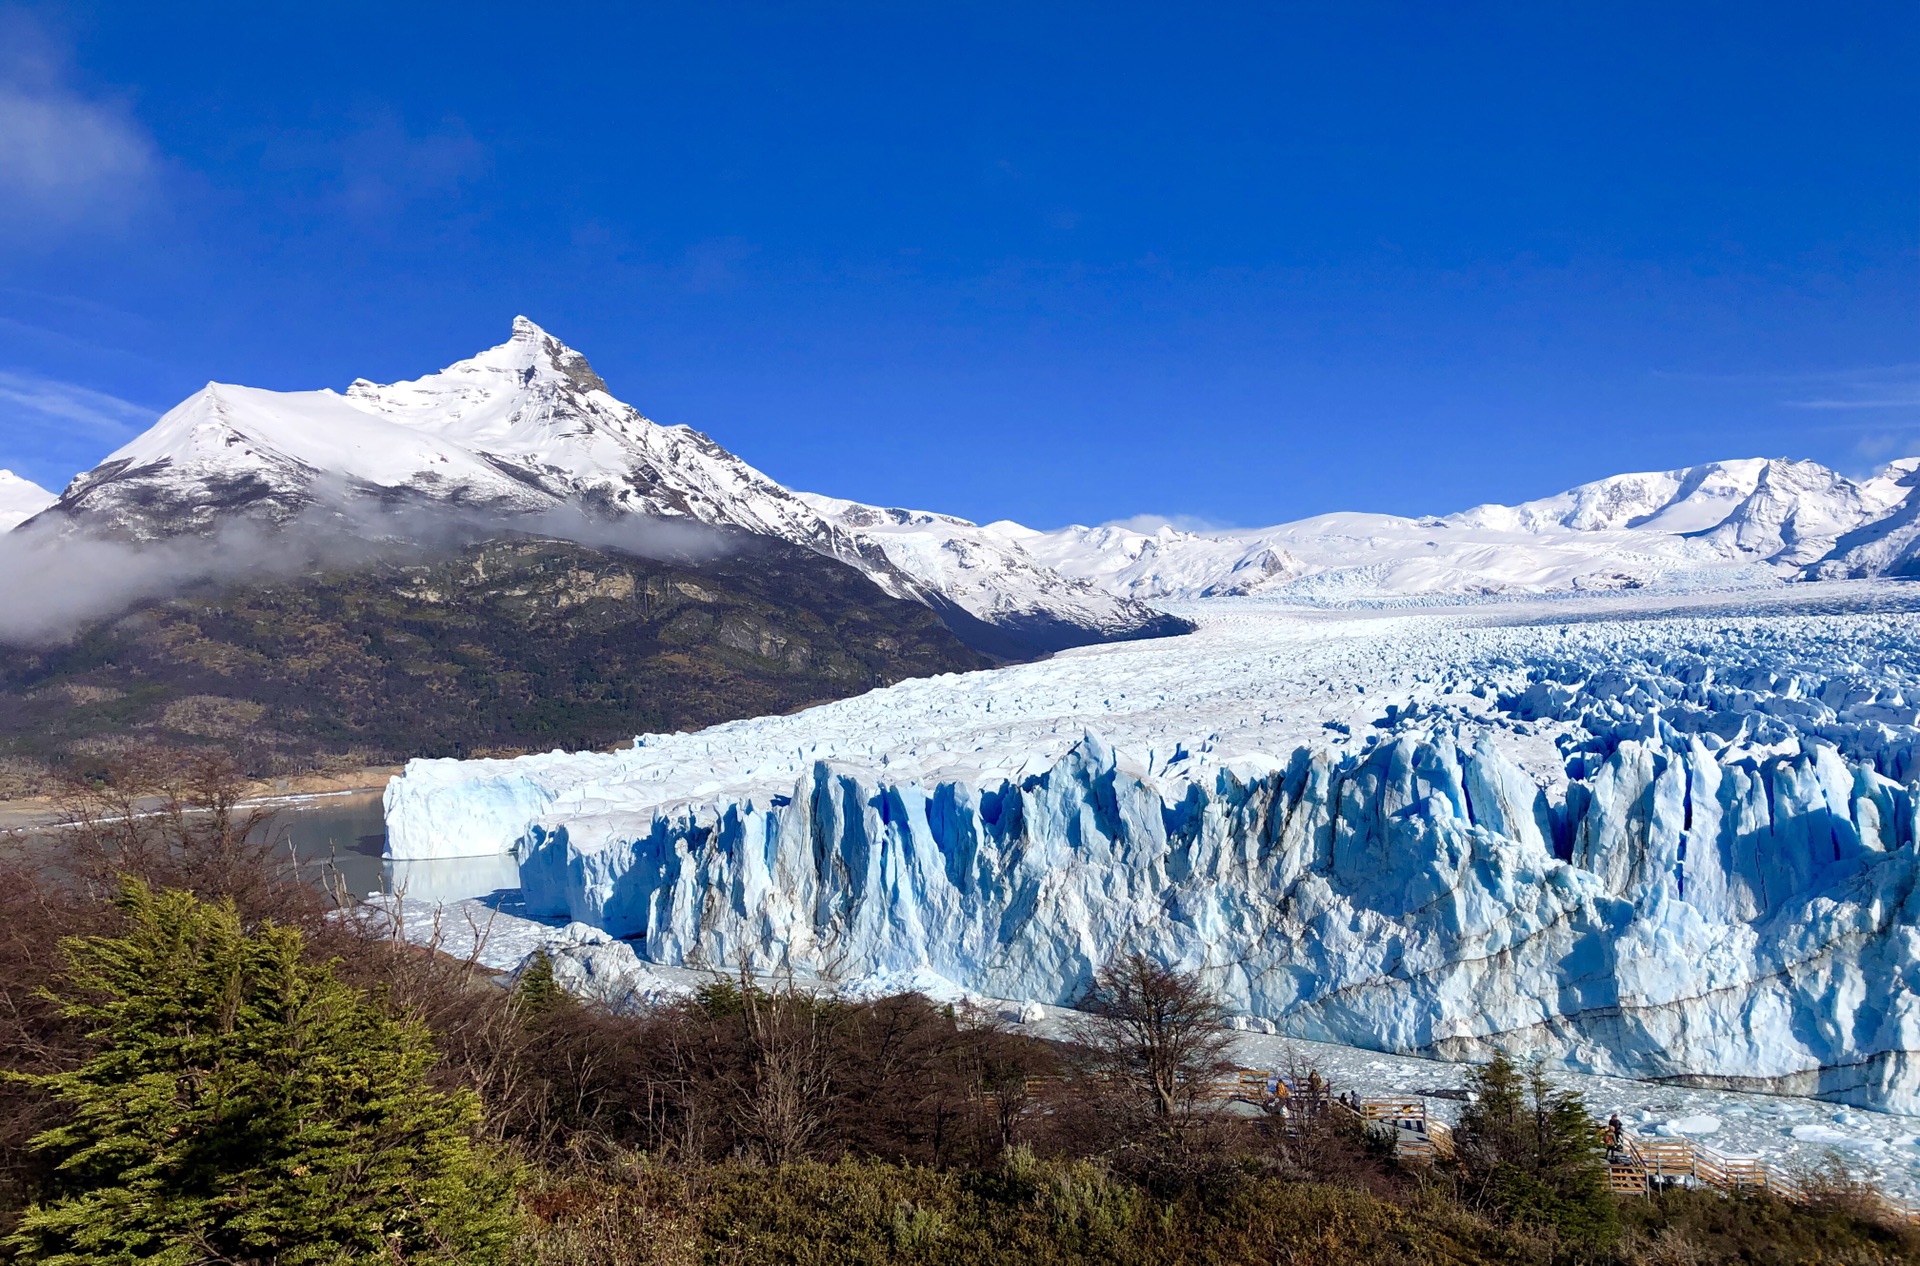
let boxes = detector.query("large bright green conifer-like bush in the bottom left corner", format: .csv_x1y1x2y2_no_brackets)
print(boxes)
10,882,513,1266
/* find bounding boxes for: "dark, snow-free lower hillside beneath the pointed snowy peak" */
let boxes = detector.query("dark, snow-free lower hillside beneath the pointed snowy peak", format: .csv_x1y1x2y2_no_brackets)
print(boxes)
0,538,987,793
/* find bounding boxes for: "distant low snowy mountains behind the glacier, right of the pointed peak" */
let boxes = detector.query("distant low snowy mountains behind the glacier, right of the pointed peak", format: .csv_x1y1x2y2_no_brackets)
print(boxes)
987,457,1920,601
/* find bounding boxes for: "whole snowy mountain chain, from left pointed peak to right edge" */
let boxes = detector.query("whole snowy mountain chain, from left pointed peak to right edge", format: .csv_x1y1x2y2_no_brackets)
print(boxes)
15,317,1920,614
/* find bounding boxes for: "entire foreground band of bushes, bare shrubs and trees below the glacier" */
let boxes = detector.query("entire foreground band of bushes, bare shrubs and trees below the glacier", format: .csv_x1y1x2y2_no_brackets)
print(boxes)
0,765,1920,1266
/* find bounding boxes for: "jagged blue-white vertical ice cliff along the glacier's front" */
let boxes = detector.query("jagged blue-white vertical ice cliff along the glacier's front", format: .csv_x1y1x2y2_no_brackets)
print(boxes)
520,732,1920,1112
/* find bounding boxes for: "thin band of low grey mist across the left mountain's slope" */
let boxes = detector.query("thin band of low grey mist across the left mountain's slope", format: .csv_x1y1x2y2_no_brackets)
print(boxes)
0,505,733,647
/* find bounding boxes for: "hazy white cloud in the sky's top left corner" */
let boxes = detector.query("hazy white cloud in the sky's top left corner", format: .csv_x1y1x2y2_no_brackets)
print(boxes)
0,13,159,234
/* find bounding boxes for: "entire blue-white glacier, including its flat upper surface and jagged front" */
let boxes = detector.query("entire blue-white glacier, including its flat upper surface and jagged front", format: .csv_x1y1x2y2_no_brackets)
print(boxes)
386,580,1920,1151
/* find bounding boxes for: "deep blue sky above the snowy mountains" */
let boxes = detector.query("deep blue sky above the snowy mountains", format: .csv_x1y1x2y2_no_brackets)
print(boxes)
0,0,1920,526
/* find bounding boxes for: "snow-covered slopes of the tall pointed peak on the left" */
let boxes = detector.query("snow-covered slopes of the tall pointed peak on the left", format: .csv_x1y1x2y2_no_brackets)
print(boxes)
22,317,1185,653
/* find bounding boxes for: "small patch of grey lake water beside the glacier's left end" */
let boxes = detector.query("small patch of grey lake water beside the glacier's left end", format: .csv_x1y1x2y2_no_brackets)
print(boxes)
273,791,520,901
